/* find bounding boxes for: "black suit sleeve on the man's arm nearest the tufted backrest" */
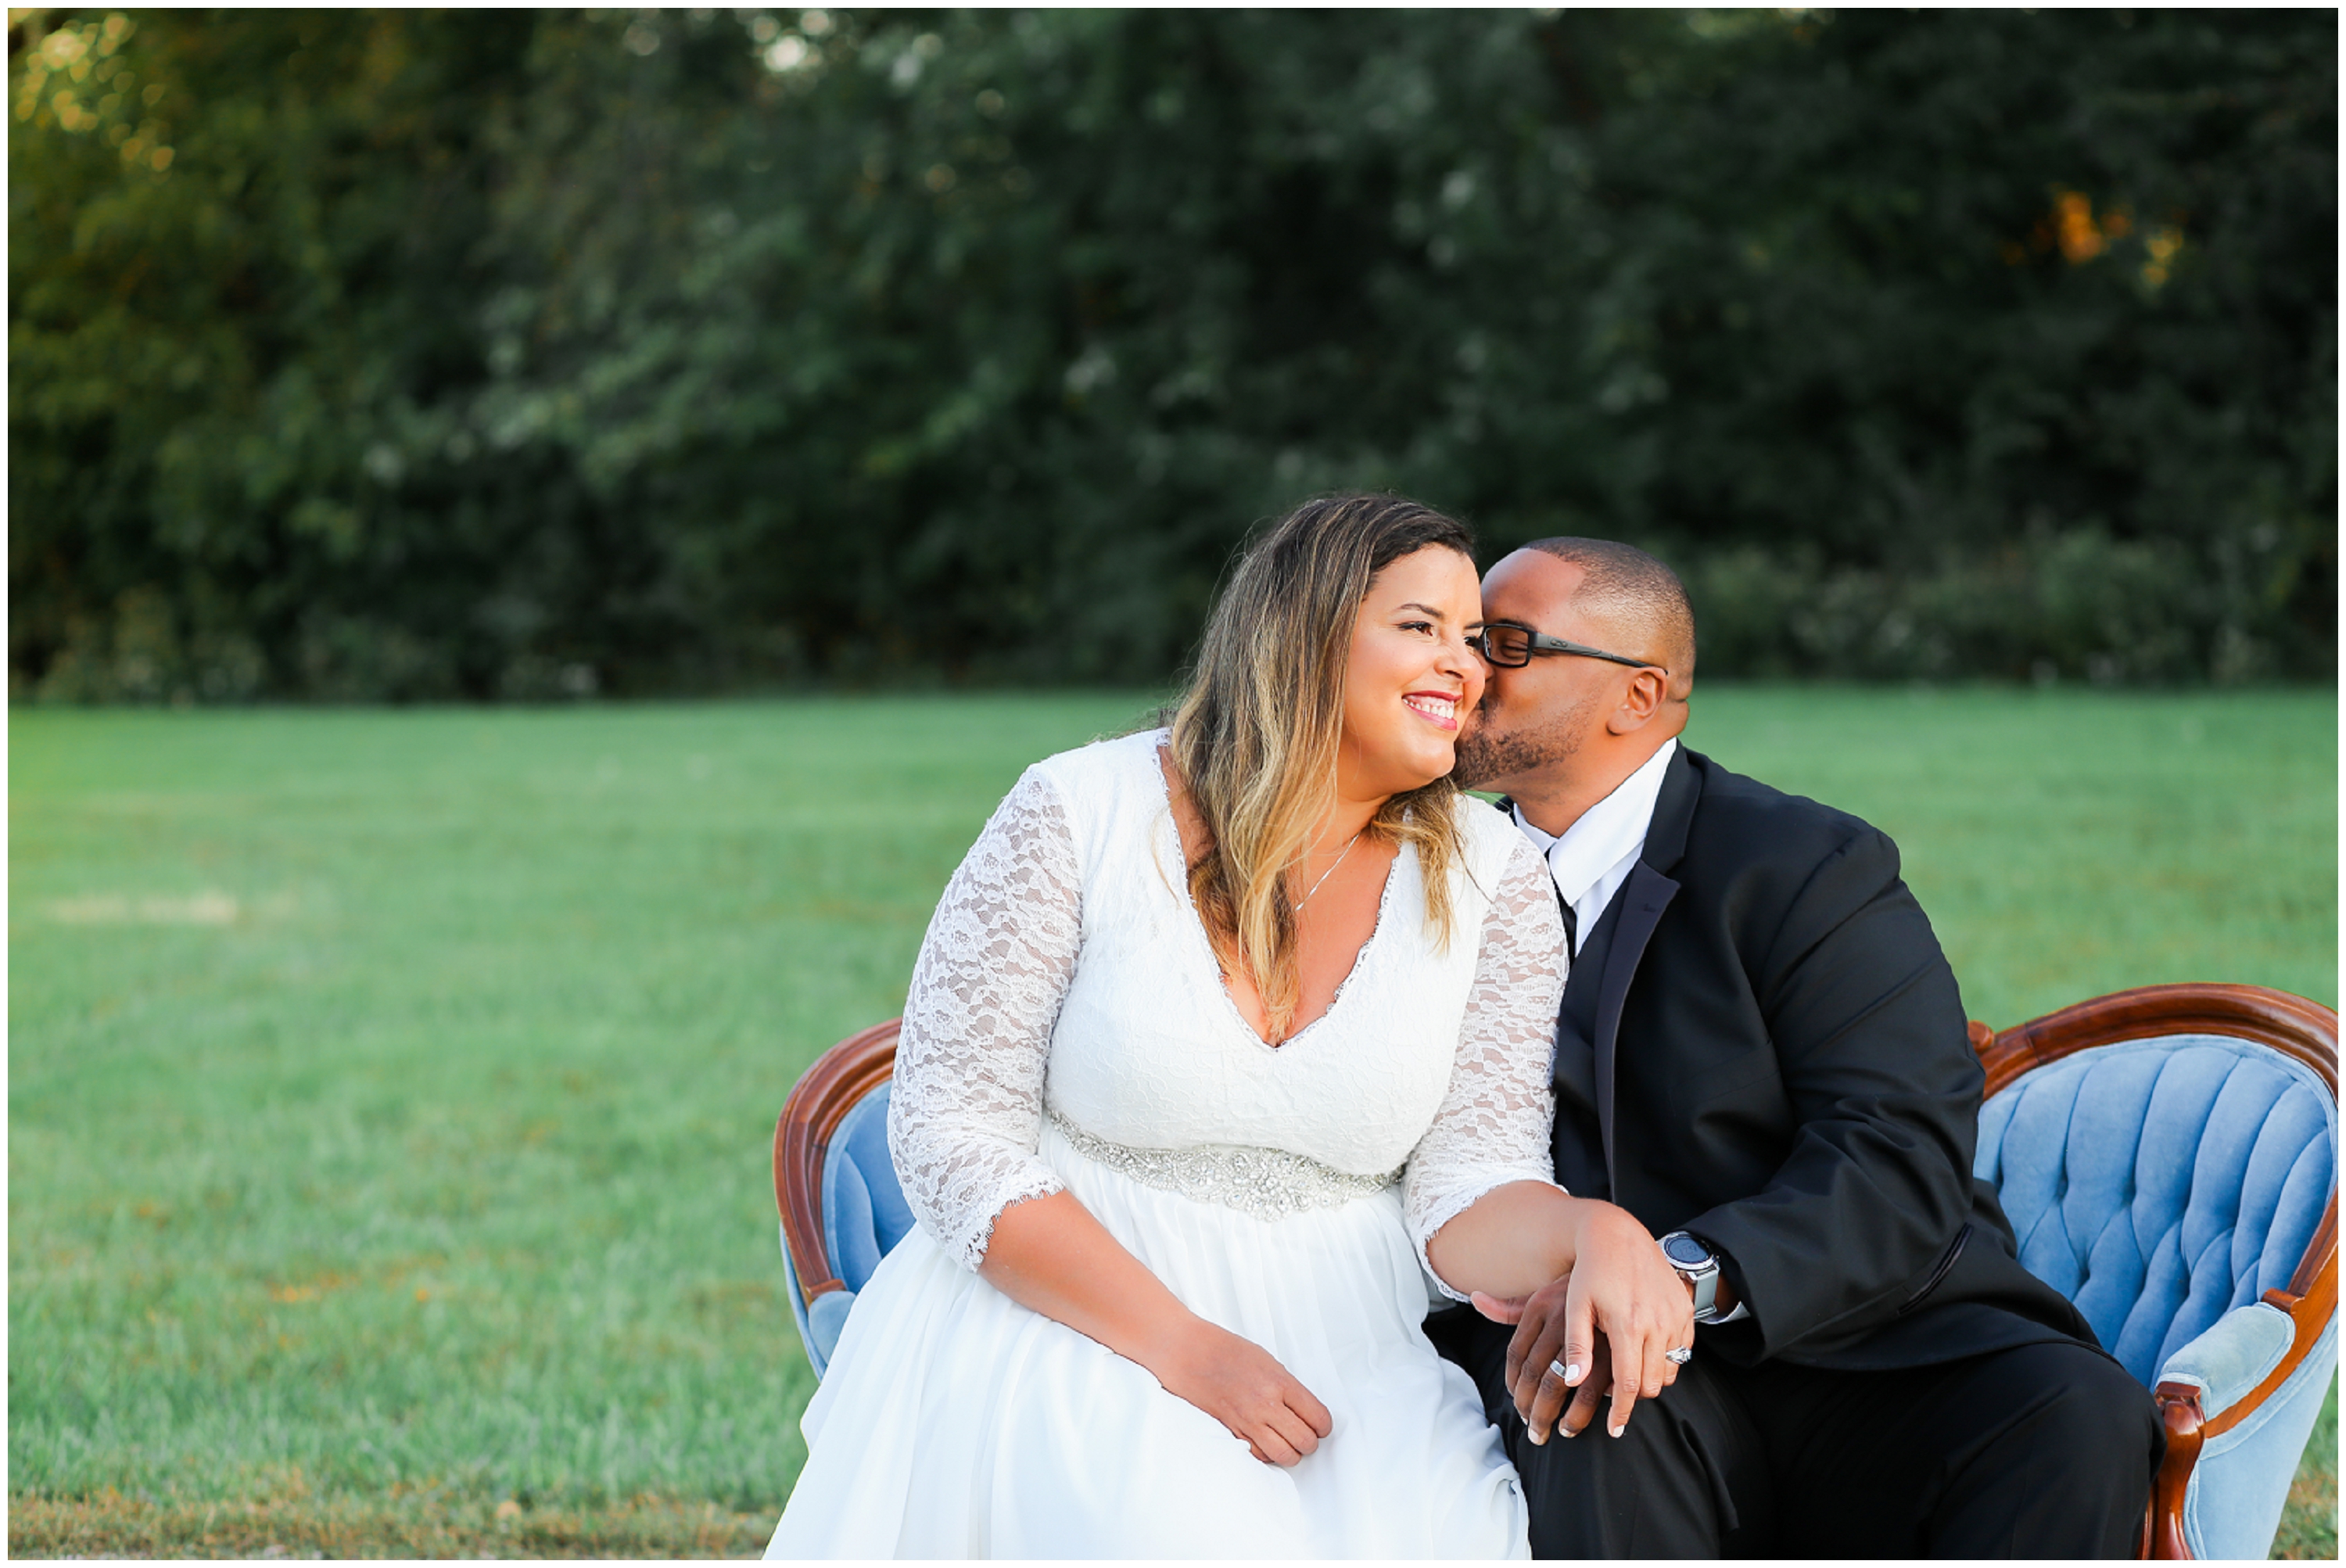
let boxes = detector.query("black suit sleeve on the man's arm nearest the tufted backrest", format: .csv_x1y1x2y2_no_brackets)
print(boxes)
1687,827,1985,1359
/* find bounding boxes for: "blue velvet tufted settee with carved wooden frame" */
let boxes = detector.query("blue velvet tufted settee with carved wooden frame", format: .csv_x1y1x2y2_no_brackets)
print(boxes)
774,986,2339,1559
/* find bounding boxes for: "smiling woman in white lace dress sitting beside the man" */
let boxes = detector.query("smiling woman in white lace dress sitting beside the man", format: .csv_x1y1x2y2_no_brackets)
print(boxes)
767,497,1684,1556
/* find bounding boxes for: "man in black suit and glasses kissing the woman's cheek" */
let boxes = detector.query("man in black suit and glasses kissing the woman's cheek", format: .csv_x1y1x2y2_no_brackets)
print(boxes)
1426,540,2163,1556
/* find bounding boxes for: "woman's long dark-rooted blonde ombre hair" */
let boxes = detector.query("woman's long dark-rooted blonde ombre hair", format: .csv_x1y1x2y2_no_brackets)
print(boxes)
1173,495,1473,1040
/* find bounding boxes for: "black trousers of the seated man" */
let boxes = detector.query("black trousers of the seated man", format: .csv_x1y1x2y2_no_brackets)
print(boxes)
1426,1310,2165,1556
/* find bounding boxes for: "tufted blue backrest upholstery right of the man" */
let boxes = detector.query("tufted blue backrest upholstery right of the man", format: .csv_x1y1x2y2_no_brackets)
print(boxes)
1975,1035,2337,1385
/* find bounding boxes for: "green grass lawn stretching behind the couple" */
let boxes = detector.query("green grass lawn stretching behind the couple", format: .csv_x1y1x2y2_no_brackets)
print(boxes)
7,687,2337,1556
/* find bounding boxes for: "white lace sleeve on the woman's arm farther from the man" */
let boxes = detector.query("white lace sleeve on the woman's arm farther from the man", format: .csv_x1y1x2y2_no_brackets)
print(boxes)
887,770,1084,1268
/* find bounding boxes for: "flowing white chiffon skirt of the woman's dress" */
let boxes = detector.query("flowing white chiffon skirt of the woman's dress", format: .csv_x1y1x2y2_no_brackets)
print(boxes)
767,1125,1530,1556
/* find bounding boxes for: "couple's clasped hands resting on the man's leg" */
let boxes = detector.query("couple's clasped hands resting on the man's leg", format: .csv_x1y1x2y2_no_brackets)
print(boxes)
1473,1202,1694,1444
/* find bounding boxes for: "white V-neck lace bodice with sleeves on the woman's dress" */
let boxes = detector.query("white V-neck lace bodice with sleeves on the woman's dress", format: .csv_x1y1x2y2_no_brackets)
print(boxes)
889,734,1562,1295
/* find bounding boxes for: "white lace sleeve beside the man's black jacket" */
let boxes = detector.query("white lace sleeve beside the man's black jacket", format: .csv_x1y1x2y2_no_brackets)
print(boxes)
1401,841,1565,1301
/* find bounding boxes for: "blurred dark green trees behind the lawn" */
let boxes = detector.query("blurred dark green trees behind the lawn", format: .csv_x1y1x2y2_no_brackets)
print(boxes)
9,9,2337,701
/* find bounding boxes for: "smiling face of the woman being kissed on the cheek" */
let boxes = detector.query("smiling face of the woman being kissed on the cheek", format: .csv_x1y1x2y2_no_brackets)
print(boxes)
1337,544,1483,801
